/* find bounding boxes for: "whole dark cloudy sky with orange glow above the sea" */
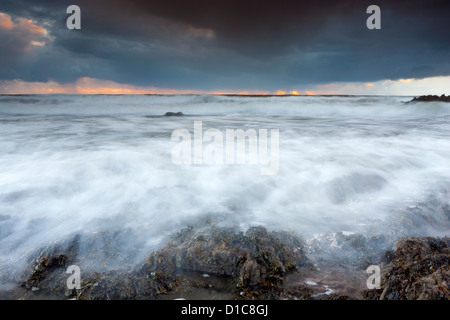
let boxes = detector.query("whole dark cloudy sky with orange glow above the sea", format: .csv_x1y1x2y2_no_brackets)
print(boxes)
0,0,450,95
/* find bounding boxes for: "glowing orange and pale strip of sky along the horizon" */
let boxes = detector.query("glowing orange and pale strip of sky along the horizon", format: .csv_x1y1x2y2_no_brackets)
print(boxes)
0,76,450,96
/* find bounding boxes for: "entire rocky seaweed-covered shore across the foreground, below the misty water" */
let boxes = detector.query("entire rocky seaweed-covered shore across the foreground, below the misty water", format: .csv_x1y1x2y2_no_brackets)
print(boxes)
0,223,450,300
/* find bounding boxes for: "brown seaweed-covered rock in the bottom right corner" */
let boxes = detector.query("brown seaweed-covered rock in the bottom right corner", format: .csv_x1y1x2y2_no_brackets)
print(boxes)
363,237,450,300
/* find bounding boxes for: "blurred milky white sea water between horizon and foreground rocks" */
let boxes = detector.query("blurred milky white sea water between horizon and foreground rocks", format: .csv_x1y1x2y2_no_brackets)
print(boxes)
0,95,450,274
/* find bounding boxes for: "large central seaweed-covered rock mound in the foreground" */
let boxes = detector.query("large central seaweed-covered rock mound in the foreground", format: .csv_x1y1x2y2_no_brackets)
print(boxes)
142,227,308,296
